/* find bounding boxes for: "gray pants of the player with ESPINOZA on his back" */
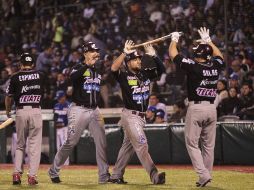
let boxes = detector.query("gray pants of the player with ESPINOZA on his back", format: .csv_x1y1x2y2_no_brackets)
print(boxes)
14,106,42,176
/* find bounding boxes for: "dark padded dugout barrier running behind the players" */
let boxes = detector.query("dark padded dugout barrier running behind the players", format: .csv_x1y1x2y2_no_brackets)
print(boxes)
0,112,254,165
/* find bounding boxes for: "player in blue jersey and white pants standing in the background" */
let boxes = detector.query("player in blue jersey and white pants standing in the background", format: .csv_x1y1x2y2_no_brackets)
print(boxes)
54,90,70,165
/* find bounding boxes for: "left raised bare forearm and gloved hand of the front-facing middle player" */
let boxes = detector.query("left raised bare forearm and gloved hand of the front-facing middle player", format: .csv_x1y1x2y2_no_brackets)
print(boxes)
111,40,135,71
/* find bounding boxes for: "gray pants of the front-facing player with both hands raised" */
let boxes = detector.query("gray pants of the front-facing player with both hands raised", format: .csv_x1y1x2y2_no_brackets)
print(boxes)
111,109,158,183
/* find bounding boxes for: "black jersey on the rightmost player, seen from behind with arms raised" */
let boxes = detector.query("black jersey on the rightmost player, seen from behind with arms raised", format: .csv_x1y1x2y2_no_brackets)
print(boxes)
174,54,225,102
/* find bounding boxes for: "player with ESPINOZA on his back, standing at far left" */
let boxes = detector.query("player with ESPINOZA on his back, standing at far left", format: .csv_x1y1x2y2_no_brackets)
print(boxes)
5,53,44,185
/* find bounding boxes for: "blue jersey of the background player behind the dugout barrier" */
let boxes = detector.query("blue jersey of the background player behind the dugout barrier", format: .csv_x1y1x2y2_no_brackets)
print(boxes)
54,101,70,126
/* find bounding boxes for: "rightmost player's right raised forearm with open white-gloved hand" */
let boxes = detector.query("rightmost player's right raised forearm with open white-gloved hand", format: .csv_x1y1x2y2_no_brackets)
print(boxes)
197,27,223,58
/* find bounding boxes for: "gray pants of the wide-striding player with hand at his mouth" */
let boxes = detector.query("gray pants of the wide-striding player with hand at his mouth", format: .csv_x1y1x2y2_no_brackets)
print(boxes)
49,103,109,182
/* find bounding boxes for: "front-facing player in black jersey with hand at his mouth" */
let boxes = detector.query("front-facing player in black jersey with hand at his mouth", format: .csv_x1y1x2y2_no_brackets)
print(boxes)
48,42,110,183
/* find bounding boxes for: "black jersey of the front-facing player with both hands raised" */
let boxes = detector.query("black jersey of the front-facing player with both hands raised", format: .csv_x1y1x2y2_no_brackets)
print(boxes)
112,58,164,112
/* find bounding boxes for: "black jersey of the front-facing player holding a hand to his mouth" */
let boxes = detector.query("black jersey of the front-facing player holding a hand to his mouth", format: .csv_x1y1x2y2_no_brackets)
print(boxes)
70,64,101,108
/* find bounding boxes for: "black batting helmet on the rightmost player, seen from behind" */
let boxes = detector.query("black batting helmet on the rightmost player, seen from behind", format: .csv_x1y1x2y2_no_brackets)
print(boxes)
193,44,213,60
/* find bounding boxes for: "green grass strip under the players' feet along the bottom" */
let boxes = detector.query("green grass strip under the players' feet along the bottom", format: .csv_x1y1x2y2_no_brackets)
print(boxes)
0,168,254,190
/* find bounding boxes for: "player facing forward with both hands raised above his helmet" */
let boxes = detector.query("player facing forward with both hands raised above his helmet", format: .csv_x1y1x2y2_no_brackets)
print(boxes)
111,40,165,184
